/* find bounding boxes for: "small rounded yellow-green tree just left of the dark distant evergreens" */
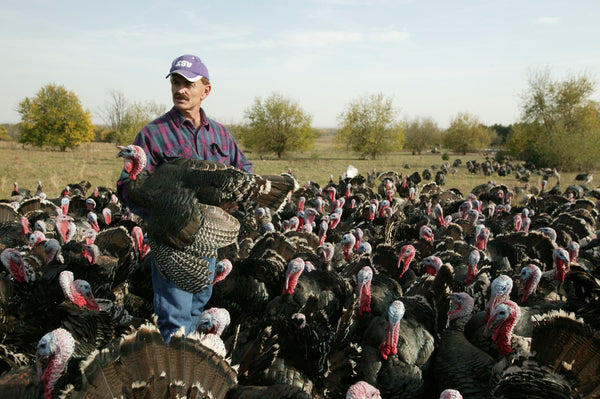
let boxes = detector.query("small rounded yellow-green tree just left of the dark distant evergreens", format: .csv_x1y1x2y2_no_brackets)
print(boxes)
442,112,491,154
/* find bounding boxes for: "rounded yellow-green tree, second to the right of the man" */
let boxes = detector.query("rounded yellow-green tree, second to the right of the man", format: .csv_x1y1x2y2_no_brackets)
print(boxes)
337,93,404,159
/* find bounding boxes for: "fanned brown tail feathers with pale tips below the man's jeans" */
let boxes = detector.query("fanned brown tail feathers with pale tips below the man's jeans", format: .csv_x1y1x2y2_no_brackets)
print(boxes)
64,324,237,399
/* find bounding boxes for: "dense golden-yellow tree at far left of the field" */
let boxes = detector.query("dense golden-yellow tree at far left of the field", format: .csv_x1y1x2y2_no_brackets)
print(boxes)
17,84,94,151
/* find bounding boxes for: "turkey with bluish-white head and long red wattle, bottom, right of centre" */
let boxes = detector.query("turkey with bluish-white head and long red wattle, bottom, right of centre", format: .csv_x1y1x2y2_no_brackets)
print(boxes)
358,265,453,398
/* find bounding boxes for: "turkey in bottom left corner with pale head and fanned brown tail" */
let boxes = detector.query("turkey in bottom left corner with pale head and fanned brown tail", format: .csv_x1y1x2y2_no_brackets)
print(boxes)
0,324,237,399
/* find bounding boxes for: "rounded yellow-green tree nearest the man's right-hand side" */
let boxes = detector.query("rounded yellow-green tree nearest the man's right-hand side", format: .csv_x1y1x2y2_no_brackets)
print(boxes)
239,93,316,159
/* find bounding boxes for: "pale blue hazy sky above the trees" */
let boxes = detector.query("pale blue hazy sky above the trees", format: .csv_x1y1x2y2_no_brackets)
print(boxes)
0,0,600,128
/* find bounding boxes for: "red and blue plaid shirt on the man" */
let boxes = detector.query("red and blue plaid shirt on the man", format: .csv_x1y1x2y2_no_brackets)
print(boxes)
117,107,252,216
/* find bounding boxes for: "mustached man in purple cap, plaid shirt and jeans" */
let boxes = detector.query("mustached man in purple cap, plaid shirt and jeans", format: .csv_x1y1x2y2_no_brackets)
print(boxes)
117,55,252,342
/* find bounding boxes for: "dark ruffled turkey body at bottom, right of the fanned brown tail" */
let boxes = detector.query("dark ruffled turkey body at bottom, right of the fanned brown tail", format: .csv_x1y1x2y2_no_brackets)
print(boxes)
233,306,360,399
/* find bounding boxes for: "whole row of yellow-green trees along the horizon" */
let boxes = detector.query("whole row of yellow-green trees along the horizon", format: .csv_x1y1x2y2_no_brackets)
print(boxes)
5,68,600,170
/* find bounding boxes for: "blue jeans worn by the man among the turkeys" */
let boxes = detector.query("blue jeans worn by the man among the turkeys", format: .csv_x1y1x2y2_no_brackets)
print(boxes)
152,258,216,343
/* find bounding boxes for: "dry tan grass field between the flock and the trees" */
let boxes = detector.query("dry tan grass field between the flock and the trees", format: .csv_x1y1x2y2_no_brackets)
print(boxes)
0,136,584,199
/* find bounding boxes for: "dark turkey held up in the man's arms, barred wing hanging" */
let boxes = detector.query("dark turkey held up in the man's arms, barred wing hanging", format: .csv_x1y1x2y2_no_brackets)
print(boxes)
118,145,298,293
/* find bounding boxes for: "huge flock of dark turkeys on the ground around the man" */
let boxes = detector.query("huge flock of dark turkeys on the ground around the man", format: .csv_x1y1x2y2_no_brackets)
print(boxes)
0,155,600,399
